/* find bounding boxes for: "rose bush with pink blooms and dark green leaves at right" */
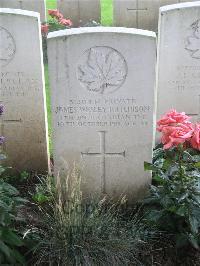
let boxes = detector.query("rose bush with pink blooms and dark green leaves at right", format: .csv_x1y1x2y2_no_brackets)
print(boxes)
144,110,200,248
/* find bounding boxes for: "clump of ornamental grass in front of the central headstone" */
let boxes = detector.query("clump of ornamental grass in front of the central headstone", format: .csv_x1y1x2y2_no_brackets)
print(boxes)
27,164,154,266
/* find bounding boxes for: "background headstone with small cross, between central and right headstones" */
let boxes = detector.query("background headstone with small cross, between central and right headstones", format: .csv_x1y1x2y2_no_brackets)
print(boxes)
113,0,197,32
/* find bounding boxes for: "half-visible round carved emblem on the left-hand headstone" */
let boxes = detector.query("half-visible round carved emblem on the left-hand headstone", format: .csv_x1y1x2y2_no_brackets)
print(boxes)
0,27,16,66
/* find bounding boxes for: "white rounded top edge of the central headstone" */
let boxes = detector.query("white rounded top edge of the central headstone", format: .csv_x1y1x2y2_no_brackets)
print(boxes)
48,27,156,39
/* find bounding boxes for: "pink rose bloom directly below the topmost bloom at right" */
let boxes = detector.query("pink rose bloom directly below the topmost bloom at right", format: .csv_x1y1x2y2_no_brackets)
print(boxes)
161,123,194,149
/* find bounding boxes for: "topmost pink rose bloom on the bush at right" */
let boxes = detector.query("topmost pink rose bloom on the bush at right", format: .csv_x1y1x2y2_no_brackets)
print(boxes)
157,110,190,132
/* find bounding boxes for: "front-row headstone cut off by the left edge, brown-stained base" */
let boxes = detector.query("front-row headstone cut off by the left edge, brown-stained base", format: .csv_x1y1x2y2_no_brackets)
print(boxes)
0,8,49,172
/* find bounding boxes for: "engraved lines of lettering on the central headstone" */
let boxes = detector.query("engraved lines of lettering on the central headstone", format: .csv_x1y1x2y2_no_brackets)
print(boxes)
54,98,151,129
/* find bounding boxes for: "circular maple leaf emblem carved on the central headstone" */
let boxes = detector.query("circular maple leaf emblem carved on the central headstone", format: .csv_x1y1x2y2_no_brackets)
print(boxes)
77,46,127,94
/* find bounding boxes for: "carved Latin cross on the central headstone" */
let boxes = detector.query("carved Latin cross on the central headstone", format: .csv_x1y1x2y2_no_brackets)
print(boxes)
81,131,125,193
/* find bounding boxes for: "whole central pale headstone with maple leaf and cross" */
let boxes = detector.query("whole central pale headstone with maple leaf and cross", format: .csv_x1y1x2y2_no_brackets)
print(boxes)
48,27,156,202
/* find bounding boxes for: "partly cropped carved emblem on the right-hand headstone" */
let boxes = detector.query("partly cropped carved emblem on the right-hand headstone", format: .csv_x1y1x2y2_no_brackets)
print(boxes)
185,19,200,59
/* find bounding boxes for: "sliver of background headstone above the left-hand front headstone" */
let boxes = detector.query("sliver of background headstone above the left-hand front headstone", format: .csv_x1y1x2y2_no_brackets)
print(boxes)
0,0,46,22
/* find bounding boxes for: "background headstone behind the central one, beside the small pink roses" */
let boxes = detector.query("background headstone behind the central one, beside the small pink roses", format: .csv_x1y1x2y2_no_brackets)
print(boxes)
57,0,101,27
